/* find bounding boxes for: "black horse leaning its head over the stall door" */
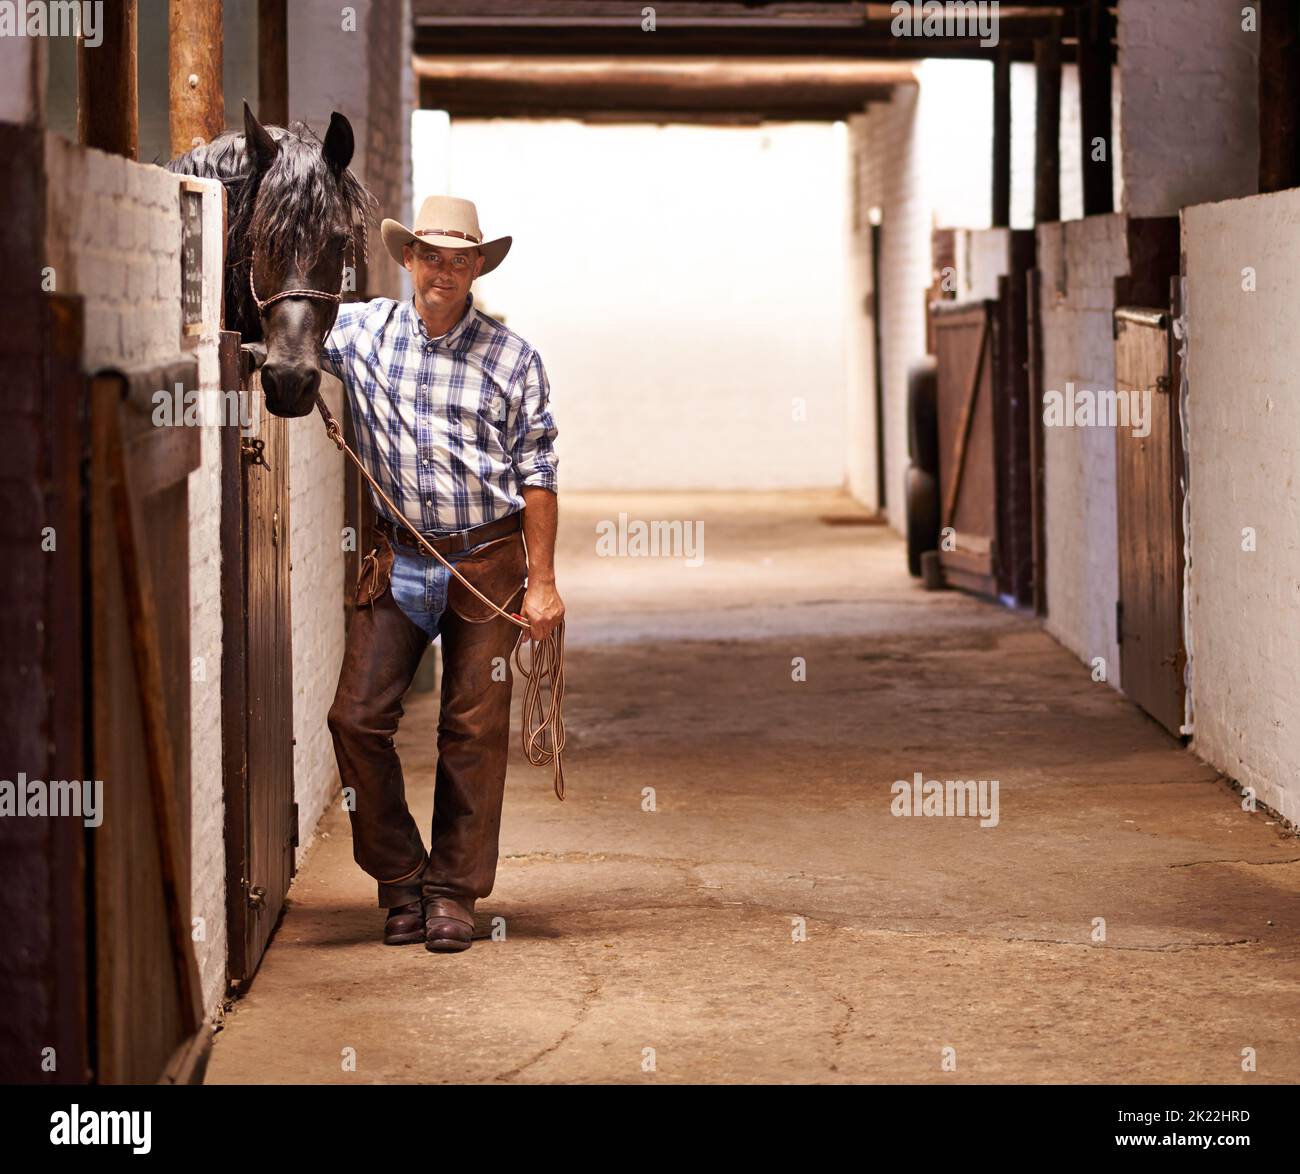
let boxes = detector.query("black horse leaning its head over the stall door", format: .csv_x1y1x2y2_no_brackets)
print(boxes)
166,103,374,416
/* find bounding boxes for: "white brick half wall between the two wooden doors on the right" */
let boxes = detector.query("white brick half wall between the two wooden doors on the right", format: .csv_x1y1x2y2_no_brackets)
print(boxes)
1037,213,1128,688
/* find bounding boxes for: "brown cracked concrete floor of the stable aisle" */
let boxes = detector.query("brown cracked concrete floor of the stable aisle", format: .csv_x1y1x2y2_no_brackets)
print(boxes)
208,494,1300,1083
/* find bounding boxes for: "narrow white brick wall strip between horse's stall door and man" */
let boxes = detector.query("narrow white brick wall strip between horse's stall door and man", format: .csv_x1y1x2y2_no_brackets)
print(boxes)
289,376,345,852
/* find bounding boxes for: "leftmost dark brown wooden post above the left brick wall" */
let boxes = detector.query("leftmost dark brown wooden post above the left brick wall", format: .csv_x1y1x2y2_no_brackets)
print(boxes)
77,0,140,159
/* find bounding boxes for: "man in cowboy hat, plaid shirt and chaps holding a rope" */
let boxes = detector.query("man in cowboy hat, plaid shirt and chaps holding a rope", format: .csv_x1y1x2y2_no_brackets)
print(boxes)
322,196,564,952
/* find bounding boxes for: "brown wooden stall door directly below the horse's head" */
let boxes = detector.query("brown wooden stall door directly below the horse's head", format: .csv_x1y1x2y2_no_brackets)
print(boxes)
221,333,298,987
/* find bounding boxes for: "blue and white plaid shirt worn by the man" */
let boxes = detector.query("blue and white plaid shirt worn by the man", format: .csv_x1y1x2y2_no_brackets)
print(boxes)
321,294,559,532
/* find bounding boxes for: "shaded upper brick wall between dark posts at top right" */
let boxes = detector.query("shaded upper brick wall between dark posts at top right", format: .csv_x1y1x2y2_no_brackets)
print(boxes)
1115,0,1260,216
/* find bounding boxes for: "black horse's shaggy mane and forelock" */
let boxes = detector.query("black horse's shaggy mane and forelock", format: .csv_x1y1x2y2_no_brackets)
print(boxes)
166,122,377,341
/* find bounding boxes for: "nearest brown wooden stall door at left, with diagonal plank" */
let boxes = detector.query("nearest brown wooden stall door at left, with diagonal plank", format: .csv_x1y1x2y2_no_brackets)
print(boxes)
87,359,209,1083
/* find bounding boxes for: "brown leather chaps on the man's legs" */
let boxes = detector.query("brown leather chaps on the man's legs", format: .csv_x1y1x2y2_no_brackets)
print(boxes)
329,530,528,923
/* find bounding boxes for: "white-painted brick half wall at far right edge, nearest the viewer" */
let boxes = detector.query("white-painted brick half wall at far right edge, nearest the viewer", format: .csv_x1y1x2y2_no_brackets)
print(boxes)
1183,190,1300,823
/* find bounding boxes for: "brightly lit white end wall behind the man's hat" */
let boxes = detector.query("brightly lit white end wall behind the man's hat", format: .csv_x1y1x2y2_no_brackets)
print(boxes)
415,120,845,489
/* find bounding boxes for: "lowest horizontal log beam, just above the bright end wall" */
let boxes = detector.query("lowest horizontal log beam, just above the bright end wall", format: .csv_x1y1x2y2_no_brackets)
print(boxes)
415,56,915,121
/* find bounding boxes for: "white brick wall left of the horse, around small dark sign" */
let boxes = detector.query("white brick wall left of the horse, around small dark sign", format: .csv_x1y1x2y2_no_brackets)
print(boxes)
46,134,226,1011
